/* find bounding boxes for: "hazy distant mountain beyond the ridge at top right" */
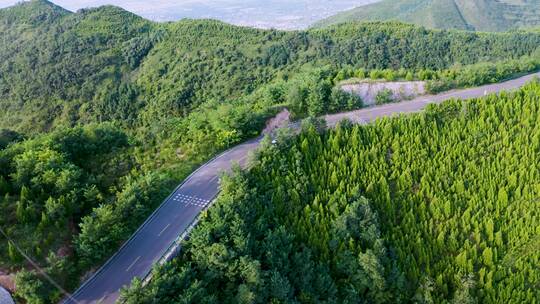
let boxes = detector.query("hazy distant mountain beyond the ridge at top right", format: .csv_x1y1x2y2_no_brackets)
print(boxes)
315,0,540,31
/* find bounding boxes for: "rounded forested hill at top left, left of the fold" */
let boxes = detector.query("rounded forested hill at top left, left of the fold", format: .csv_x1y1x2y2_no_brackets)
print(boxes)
0,0,156,131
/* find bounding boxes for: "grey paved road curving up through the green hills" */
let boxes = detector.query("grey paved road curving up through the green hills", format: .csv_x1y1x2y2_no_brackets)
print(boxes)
65,73,540,304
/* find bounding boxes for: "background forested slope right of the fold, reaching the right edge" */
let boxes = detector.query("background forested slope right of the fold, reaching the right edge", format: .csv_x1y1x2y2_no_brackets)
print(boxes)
135,20,540,122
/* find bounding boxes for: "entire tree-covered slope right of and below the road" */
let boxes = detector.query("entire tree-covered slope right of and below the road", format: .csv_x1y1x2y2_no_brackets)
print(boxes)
123,82,540,303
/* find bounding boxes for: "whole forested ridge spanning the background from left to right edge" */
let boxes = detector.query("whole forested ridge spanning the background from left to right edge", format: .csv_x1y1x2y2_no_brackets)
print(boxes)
0,0,540,133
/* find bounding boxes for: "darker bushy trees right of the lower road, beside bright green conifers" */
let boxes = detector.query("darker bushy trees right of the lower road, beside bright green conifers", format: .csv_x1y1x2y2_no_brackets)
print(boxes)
123,164,403,303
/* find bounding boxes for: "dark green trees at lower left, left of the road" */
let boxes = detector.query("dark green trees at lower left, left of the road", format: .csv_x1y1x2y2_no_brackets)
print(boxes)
0,124,171,303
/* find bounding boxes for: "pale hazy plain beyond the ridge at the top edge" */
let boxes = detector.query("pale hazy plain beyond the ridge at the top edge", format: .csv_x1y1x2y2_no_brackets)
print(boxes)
0,0,378,29
